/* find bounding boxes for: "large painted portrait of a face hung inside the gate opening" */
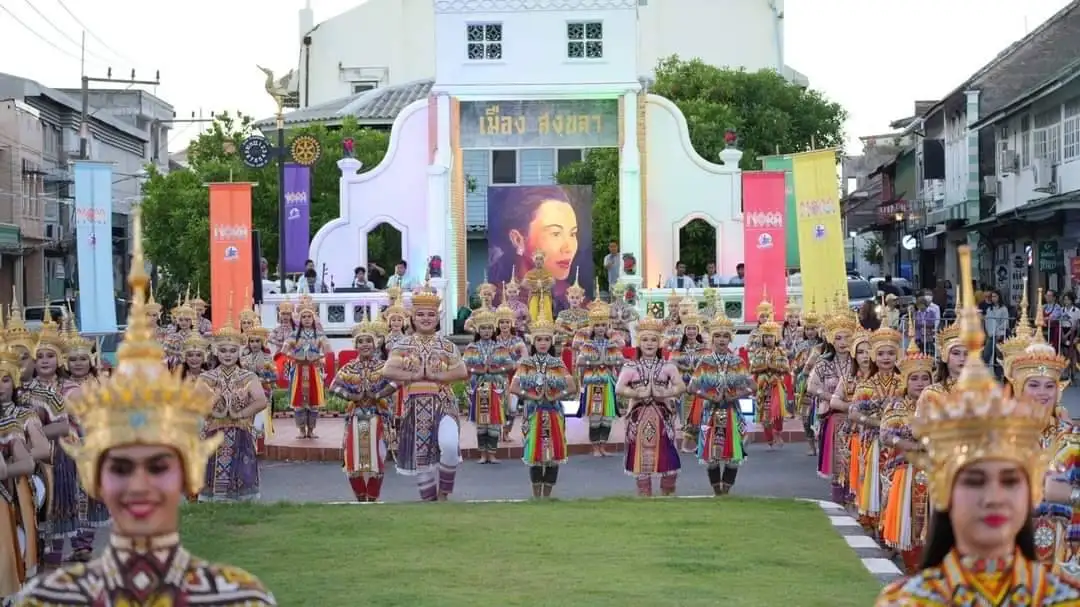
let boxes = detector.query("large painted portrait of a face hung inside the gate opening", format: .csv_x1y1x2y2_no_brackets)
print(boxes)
487,186,595,314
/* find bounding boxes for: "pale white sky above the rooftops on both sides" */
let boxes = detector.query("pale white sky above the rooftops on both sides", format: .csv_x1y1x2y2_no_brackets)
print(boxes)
0,0,1068,153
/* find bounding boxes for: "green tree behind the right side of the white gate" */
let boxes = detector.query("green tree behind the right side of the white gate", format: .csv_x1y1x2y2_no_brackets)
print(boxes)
557,56,847,273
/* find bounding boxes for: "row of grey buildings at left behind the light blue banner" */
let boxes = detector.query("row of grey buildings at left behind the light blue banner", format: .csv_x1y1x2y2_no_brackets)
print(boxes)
0,73,174,304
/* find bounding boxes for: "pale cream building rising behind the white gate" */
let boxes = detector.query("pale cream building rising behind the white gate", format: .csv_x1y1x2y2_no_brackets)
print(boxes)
296,0,808,108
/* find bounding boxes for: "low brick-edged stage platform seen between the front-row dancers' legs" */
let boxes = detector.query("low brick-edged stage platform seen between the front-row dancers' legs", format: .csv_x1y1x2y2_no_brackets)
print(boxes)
264,416,806,461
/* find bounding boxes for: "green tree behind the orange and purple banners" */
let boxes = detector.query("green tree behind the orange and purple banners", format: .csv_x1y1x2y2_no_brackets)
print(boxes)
143,113,390,301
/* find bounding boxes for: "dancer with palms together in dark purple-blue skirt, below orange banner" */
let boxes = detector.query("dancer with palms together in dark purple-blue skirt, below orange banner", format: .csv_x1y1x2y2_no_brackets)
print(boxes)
199,314,267,502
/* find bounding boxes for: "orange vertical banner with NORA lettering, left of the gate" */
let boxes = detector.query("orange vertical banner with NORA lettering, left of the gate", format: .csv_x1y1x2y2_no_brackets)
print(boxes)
210,184,254,329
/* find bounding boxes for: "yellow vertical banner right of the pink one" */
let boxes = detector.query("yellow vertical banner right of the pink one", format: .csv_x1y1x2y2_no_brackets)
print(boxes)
792,149,848,312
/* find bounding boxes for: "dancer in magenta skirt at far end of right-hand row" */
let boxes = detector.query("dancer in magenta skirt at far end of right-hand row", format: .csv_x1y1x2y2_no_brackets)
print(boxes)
807,300,859,503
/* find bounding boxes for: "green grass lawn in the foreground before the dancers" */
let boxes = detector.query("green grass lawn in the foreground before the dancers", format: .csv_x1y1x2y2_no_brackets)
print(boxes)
183,497,880,607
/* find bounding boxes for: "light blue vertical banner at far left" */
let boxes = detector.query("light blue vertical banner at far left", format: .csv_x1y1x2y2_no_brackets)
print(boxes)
73,160,117,333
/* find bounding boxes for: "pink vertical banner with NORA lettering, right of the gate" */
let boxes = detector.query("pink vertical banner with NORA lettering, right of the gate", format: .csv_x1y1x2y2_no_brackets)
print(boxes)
743,171,787,323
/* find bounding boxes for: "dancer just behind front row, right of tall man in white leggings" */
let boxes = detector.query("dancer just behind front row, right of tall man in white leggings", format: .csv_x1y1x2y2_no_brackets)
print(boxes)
461,310,514,463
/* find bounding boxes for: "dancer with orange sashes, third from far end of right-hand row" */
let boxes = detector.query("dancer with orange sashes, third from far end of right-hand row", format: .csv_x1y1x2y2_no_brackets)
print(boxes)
848,326,906,535
